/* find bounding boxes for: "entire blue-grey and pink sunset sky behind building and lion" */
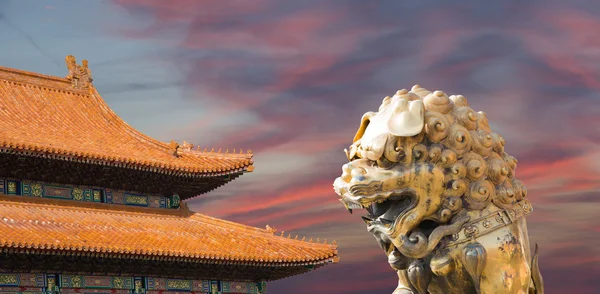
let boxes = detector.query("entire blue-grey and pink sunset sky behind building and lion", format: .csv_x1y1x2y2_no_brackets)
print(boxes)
0,0,600,294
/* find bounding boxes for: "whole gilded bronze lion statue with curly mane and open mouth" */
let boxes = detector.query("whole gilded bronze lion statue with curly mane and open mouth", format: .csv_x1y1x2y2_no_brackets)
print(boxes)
333,85,544,294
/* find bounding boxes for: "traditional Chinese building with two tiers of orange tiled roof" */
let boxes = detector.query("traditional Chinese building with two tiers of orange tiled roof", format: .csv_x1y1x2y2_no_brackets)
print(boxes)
0,56,338,293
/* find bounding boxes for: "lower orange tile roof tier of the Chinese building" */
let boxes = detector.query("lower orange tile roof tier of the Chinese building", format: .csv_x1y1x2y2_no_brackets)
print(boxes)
0,194,338,266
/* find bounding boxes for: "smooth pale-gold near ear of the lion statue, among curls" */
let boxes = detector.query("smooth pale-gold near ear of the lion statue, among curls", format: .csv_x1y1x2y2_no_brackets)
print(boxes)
387,99,425,137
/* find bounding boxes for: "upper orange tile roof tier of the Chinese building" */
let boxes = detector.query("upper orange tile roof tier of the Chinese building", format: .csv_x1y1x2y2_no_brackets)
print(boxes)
0,62,254,176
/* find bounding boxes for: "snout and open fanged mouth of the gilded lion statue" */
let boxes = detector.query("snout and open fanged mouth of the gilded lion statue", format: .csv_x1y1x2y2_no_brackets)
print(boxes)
334,159,468,260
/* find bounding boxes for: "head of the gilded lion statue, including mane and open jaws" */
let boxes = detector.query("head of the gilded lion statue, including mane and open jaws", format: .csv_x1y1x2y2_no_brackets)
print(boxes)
334,85,526,269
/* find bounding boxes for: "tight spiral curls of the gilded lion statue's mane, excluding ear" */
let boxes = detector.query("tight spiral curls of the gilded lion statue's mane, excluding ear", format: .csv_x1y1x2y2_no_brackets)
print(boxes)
347,85,527,218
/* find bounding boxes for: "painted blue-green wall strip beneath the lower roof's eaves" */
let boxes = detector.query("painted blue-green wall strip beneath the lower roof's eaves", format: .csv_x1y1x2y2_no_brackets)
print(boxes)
0,272,266,294
